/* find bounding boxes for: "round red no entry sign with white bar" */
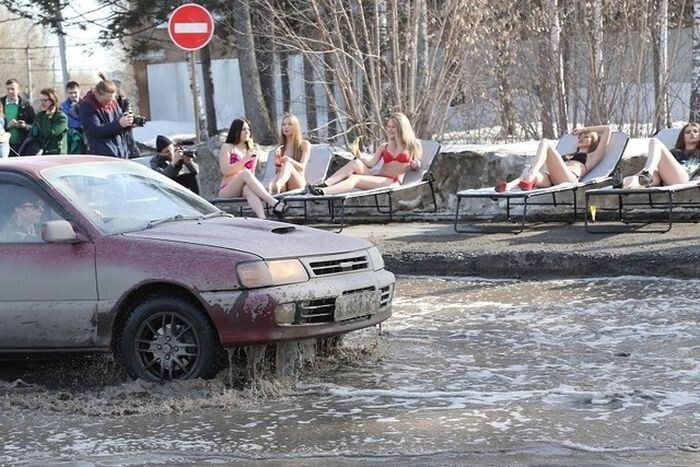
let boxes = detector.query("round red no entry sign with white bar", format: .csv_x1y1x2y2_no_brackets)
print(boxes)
168,3,214,50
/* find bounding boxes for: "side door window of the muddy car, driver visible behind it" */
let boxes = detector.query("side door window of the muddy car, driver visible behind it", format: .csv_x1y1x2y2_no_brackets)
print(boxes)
0,183,62,244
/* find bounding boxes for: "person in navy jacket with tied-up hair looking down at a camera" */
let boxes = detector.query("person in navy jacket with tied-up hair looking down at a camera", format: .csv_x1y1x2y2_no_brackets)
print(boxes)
78,79,134,159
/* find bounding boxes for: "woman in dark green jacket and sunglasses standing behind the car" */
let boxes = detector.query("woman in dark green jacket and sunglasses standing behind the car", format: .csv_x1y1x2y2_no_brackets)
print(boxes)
32,88,68,156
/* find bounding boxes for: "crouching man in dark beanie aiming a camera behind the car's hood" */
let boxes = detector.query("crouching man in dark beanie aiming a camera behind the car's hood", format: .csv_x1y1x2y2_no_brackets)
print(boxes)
151,135,199,194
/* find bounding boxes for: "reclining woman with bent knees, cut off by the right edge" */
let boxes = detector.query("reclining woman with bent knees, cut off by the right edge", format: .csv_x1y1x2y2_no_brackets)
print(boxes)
614,123,700,188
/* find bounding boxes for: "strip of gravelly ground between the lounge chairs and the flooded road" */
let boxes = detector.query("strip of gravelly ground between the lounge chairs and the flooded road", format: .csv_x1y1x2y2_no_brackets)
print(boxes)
343,222,700,279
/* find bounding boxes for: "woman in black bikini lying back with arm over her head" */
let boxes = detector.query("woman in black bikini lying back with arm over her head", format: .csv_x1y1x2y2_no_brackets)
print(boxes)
496,125,610,192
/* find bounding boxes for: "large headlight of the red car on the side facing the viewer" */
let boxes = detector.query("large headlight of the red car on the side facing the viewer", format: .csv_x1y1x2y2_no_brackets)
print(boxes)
236,259,309,289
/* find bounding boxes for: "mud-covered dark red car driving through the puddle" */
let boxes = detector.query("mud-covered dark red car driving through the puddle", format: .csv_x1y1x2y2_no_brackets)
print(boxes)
0,156,394,381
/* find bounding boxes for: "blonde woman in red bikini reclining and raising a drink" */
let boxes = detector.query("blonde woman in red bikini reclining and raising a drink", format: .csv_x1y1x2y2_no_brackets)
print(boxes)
306,112,422,195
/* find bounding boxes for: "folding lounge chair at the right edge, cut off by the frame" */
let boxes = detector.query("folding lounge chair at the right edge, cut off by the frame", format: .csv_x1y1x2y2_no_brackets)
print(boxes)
585,128,700,233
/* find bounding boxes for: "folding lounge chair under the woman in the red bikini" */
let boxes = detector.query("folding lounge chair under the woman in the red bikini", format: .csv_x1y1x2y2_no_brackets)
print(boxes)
285,140,440,232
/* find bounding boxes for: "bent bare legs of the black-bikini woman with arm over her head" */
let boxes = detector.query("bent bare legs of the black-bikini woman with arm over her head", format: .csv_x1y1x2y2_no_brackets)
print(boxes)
504,140,583,191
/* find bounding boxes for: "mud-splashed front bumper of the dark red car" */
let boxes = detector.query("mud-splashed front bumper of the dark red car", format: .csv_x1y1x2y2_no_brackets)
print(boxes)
201,270,395,347
